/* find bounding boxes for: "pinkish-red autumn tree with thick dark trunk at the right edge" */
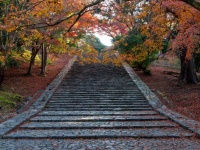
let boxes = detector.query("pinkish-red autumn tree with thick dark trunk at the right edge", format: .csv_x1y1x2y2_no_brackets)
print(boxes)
163,1,200,83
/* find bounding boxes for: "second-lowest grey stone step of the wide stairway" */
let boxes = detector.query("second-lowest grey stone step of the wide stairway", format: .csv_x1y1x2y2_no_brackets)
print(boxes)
20,121,177,129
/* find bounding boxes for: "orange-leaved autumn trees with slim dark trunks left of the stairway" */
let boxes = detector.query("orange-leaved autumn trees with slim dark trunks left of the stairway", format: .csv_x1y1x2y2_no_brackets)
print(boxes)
0,0,103,81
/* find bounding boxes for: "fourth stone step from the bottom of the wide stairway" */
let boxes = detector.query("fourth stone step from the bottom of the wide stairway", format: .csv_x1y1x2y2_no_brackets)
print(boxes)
38,111,158,116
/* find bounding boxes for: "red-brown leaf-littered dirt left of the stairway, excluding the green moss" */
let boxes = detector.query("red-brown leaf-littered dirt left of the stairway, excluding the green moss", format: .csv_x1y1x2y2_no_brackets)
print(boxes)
0,55,69,122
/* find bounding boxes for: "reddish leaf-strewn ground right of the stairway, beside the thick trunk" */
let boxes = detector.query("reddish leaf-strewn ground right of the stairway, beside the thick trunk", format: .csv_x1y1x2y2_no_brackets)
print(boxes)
136,66,200,122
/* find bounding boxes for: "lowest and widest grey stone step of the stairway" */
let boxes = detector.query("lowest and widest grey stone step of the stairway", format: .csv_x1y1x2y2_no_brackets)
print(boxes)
4,128,193,139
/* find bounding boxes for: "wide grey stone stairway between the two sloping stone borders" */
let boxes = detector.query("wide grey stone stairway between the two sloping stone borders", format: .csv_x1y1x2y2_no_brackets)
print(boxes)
5,63,194,139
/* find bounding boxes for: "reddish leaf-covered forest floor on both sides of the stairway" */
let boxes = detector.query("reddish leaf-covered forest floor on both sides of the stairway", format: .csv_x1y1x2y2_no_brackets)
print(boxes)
0,55,200,122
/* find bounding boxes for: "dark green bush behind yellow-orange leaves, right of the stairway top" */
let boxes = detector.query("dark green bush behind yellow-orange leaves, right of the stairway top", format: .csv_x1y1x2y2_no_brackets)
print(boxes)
114,29,159,75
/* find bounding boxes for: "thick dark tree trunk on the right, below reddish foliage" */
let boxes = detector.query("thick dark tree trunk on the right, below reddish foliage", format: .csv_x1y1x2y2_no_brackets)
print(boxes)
179,51,199,84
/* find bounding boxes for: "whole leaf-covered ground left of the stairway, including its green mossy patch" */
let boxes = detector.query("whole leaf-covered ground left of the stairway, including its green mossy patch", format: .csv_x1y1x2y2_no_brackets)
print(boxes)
0,55,69,122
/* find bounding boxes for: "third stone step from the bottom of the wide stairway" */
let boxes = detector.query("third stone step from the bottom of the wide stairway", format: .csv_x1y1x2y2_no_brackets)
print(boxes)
30,115,167,122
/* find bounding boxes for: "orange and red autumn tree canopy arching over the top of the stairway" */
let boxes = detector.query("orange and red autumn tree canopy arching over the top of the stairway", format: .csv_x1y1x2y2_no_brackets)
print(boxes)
0,0,200,83
